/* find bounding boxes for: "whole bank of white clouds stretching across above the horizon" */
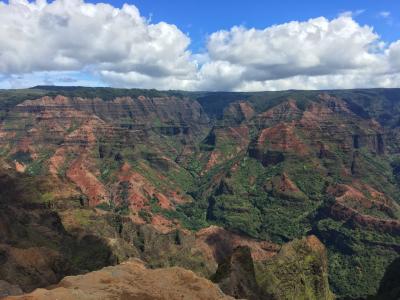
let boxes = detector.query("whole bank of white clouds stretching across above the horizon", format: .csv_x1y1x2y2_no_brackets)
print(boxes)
0,0,400,90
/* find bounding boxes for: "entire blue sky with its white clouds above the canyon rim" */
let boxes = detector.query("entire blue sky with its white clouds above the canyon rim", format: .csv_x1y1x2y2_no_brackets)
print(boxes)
0,0,400,91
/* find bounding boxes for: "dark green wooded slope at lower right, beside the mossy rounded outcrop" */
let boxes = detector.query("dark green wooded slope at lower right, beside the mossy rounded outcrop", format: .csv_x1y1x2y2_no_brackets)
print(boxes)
316,219,400,298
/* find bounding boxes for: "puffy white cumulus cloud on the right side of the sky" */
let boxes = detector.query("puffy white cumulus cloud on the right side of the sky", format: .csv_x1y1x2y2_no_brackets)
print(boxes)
208,17,378,79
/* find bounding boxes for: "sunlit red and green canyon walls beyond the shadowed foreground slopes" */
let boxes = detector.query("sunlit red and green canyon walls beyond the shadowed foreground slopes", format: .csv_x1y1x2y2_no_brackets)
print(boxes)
0,87,400,297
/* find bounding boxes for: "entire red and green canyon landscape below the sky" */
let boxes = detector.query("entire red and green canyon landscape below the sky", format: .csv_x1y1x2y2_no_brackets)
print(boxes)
0,86,400,299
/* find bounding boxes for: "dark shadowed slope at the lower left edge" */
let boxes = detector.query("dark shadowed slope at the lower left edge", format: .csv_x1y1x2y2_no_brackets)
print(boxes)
0,166,117,296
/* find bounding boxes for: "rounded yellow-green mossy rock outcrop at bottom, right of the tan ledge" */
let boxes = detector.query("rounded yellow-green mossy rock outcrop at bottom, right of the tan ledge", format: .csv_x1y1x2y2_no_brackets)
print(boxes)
256,236,334,300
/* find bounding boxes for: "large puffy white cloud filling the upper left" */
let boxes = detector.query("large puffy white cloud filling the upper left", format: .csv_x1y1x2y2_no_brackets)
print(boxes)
0,0,196,88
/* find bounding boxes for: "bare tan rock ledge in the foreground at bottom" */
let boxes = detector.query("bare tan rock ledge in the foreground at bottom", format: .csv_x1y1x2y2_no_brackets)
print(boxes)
5,260,233,300
